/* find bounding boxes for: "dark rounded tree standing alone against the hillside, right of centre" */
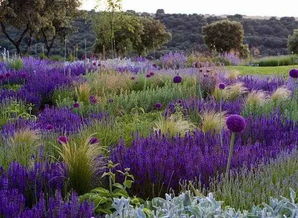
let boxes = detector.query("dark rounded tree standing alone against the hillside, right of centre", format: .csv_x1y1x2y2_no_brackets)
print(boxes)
203,20,244,53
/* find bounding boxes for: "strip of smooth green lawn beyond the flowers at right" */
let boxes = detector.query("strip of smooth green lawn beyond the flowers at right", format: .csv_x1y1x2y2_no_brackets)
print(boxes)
227,65,298,76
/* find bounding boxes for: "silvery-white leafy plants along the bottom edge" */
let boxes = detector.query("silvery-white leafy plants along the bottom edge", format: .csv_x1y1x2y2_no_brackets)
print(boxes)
106,189,298,218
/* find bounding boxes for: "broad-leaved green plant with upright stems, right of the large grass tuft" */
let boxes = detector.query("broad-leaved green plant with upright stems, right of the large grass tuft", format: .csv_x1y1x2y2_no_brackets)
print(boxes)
80,161,141,214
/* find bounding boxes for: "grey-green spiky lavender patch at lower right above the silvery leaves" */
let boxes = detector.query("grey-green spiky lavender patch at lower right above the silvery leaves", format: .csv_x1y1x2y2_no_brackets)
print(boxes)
208,151,298,209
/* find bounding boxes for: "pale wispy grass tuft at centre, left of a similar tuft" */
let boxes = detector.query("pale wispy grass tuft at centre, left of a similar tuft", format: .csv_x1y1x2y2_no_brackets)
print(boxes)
153,113,195,136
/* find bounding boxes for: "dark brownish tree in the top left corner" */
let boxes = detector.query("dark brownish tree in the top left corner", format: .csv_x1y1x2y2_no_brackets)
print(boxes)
0,0,44,54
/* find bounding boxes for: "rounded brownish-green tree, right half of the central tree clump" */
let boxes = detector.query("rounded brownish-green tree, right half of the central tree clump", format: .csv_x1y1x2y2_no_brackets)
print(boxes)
137,17,172,55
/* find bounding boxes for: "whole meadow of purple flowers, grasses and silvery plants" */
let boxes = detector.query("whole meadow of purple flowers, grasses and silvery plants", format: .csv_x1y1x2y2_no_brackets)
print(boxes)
0,53,298,218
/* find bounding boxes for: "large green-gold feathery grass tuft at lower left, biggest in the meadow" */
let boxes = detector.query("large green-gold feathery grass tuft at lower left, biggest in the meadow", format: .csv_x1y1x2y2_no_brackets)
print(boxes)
57,136,103,194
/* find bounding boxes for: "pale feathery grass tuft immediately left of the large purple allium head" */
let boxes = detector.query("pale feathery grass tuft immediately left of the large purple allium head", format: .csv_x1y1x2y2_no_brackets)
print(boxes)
201,111,226,133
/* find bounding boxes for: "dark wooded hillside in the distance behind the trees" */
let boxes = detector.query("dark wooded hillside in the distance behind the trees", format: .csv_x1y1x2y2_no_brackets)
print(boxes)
0,10,298,56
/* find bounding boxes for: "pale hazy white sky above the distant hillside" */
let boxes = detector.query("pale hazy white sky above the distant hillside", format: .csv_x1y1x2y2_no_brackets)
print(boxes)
82,0,298,17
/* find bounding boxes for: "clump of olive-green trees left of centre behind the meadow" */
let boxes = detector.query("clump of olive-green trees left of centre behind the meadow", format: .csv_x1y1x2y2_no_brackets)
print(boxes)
94,12,171,56
